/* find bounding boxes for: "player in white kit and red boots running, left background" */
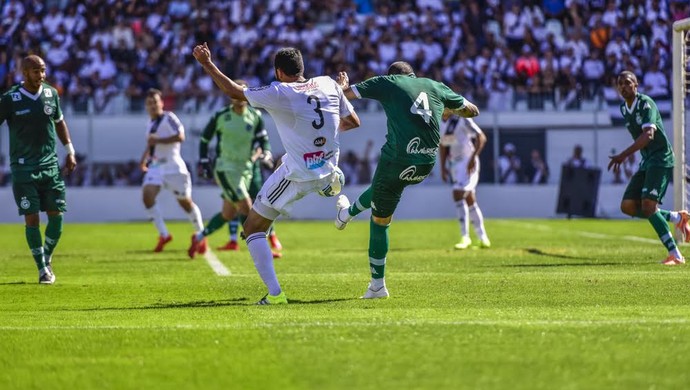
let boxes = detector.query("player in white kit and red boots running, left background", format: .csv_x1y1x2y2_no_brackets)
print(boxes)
141,89,207,253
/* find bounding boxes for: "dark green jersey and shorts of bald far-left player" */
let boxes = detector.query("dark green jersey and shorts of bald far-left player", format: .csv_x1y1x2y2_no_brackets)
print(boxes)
0,83,66,215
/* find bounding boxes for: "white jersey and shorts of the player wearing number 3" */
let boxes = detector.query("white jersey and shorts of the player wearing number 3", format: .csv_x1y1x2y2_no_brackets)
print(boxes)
244,76,354,220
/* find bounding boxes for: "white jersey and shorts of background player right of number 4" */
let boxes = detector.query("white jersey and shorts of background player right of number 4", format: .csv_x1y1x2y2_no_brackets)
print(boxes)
441,115,482,191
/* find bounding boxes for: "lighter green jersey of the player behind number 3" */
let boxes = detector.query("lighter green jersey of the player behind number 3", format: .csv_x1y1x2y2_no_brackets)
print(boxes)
199,105,270,171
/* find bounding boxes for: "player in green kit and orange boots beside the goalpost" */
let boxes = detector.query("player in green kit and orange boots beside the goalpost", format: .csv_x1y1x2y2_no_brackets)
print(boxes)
608,70,690,265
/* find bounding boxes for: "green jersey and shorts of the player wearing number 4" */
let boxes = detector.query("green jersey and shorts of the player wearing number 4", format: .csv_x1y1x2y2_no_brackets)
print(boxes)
353,75,465,217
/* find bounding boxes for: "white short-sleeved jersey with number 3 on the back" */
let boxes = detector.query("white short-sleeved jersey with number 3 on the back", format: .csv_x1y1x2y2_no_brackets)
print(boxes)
244,76,354,182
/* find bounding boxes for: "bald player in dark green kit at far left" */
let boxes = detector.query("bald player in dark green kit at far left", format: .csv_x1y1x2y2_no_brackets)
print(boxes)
0,55,77,284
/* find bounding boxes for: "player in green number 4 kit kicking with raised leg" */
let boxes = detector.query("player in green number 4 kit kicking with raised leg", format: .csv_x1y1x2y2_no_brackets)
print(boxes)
335,61,479,298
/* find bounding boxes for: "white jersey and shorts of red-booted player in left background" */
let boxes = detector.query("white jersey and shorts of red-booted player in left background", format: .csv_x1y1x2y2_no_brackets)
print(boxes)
143,111,192,198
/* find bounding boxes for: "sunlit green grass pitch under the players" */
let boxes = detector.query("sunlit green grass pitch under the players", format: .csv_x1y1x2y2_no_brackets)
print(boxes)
0,218,690,389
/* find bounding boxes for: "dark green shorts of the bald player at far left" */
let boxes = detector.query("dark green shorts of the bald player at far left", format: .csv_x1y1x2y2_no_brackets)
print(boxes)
12,166,67,215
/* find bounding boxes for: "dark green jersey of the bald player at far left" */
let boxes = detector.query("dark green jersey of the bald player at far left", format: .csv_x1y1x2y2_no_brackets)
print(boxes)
0,83,63,172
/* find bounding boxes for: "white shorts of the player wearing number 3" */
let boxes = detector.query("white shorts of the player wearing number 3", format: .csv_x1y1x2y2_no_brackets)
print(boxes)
253,164,332,221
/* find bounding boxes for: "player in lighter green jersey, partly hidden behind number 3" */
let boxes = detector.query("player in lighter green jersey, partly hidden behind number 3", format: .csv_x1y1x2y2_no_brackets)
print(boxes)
188,80,278,258
